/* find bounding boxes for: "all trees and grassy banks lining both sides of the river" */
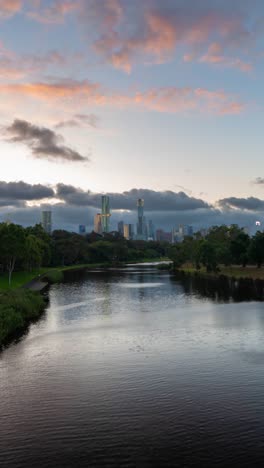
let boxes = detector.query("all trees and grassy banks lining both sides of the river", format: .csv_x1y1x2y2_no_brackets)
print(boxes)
0,223,264,346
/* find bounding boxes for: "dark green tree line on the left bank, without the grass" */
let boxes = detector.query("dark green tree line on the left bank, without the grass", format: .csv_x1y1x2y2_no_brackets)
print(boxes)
0,223,169,284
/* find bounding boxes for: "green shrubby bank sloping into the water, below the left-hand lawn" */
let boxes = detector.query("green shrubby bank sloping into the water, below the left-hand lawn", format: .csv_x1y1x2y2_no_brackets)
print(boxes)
0,289,45,348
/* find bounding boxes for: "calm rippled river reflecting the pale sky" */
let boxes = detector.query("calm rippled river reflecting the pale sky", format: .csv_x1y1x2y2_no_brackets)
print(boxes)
0,266,264,468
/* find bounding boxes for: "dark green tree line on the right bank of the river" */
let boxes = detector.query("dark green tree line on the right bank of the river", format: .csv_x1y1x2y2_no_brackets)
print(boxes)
169,224,264,272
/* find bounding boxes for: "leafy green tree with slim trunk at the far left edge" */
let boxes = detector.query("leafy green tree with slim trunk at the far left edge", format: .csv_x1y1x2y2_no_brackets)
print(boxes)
0,223,25,286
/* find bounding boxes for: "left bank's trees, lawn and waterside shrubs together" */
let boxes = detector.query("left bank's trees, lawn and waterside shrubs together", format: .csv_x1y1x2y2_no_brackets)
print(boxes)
0,223,168,347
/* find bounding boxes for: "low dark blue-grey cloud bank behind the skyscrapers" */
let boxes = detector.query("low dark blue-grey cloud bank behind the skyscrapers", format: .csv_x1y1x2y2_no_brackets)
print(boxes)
0,181,264,232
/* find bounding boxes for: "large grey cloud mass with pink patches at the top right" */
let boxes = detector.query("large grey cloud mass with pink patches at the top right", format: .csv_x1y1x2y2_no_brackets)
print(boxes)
87,0,261,73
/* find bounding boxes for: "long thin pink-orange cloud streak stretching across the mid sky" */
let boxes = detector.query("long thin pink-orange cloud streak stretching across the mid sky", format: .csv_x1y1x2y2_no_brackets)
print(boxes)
0,80,245,115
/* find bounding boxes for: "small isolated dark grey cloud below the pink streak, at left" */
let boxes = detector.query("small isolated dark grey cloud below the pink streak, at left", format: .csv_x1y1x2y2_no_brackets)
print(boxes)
6,119,88,162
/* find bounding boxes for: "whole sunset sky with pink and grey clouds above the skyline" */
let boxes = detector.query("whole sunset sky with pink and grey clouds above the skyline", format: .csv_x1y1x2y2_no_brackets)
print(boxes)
0,0,264,230
